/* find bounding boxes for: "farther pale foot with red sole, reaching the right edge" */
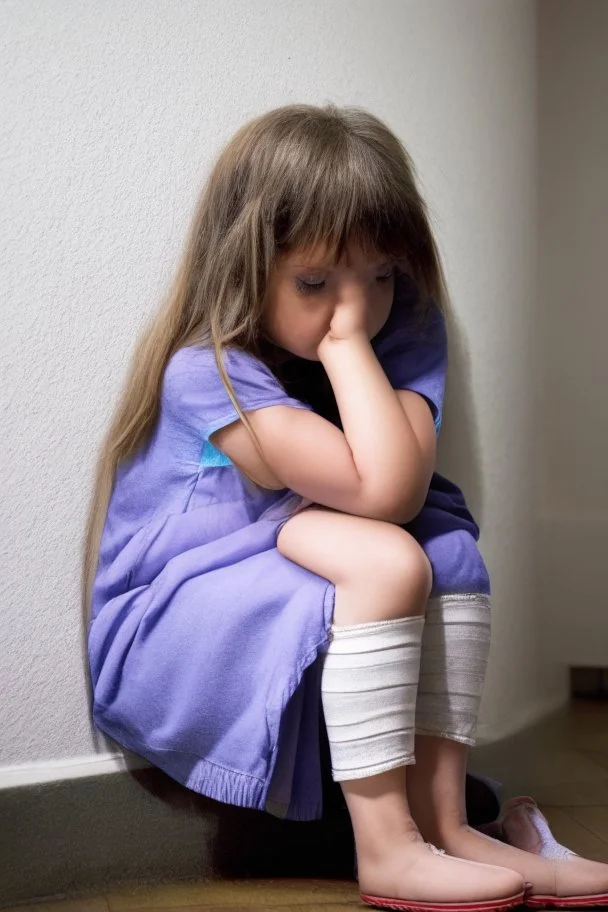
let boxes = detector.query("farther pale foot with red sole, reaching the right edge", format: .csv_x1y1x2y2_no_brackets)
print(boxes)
437,812,608,907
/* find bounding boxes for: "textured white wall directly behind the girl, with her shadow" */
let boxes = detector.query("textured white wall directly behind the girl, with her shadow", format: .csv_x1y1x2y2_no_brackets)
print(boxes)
0,0,563,784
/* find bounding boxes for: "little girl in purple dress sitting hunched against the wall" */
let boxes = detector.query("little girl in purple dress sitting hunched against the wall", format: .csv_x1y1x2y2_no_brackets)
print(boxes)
84,104,608,912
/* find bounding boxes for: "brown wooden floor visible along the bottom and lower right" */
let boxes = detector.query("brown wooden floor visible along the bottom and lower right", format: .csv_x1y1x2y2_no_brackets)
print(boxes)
4,701,608,912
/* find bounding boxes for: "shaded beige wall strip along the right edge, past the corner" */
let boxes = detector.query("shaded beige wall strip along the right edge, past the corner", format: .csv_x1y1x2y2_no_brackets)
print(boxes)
539,0,608,667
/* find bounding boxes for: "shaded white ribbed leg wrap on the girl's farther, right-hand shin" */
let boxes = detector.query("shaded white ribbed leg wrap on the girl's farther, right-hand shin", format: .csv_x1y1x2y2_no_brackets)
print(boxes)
416,594,490,746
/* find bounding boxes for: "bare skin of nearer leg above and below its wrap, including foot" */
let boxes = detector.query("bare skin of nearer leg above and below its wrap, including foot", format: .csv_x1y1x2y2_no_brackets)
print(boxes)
277,508,523,904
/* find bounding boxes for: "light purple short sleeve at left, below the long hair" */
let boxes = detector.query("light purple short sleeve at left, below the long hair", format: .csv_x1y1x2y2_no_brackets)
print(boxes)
163,346,312,440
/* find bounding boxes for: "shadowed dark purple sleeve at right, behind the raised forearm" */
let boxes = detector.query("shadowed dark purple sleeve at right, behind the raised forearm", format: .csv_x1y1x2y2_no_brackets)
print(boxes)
372,276,447,434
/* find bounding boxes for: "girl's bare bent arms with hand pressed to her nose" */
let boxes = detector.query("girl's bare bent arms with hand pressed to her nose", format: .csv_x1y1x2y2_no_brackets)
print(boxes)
213,305,436,523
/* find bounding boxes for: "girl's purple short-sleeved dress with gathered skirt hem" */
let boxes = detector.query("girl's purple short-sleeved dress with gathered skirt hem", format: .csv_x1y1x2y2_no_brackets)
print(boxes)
88,274,489,820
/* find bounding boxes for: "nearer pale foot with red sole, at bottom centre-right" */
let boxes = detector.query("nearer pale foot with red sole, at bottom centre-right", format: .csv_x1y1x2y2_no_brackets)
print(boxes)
358,842,524,912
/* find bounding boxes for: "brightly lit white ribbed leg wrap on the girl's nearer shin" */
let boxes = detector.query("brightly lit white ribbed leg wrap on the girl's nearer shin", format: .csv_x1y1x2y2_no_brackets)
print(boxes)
321,616,424,781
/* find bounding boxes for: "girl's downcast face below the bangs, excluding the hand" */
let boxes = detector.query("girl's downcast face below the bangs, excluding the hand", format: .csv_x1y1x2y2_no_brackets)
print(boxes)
264,244,395,361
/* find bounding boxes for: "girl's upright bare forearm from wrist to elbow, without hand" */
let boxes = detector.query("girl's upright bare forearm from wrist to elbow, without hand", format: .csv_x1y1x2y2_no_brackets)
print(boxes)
319,333,428,522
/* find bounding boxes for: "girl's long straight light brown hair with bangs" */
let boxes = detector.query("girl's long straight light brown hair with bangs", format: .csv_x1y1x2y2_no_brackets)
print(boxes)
82,103,447,628
